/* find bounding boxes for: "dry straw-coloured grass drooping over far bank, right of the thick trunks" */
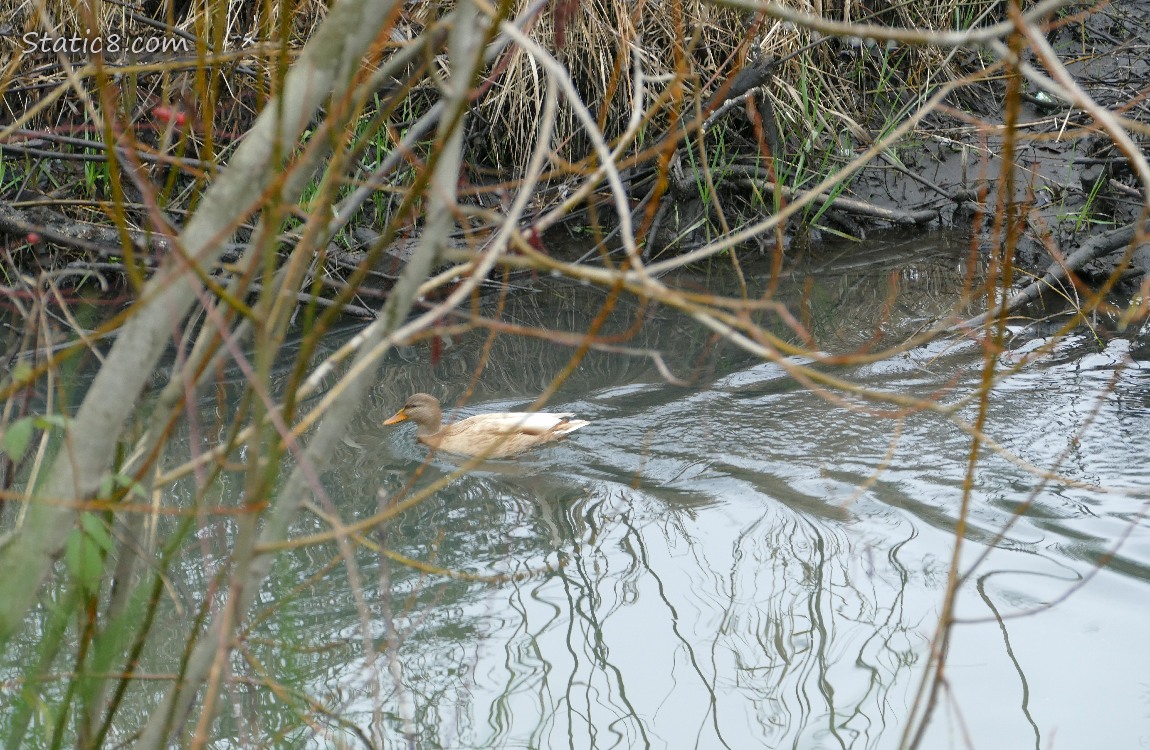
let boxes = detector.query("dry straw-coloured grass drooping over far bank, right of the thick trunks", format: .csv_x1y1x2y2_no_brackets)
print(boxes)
471,0,996,175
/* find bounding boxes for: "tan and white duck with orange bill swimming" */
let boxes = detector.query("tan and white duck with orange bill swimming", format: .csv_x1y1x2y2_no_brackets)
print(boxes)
383,393,590,458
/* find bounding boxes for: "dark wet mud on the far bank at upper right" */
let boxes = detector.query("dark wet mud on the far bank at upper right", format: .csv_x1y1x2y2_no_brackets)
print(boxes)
851,1,1150,285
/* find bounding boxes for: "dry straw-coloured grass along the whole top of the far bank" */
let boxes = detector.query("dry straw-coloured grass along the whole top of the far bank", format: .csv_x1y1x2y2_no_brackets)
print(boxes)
0,0,995,200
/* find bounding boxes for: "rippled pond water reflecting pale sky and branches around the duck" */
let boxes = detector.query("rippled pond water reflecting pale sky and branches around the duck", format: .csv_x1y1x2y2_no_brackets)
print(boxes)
2,235,1150,749
